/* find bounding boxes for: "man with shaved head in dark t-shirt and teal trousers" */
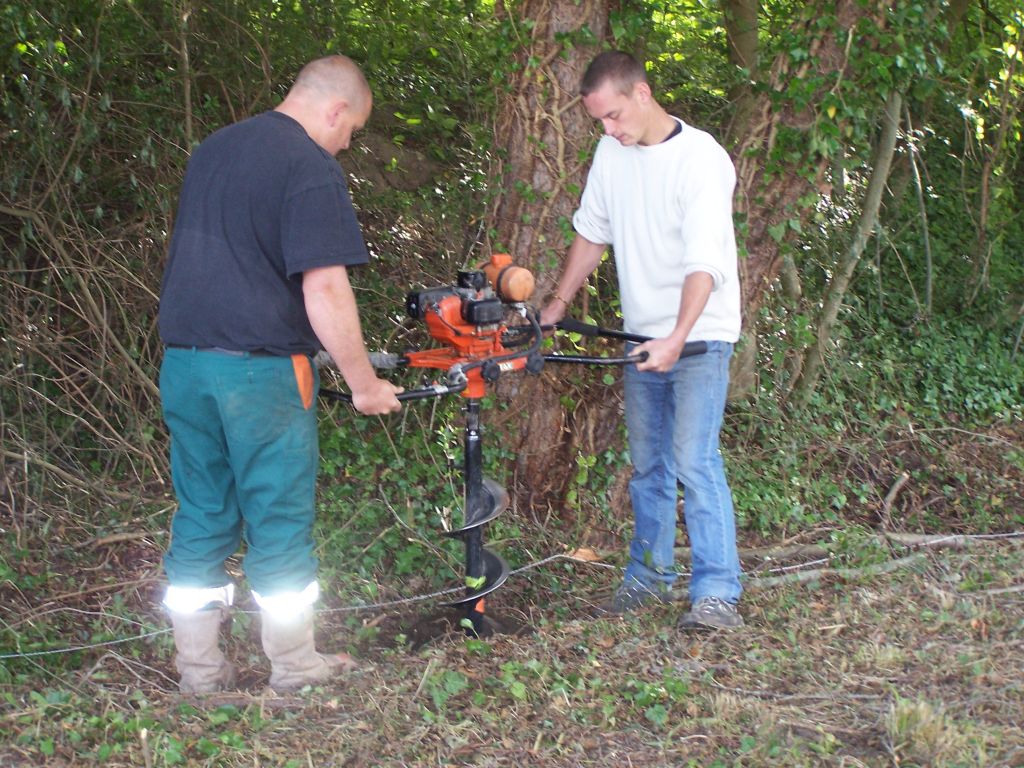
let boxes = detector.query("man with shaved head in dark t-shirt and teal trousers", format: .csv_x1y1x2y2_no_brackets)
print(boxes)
160,56,401,692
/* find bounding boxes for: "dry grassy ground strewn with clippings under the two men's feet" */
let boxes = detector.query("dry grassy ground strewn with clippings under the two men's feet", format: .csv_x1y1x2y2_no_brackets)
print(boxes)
0,539,1024,768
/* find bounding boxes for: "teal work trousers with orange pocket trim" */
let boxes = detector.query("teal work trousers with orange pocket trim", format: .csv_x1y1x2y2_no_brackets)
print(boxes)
160,348,319,595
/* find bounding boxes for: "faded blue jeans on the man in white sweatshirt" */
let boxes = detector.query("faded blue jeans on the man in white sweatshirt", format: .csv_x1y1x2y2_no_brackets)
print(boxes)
625,341,742,603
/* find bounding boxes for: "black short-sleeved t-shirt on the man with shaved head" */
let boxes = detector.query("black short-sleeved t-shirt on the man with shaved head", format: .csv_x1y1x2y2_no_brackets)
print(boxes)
160,112,368,354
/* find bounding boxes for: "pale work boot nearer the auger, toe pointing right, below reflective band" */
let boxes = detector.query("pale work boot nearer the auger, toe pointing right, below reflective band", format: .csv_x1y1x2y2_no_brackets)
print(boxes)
260,606,356,690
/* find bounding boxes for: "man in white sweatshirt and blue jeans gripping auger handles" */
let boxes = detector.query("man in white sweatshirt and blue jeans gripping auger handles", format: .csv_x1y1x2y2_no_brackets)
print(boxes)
541,51,743,629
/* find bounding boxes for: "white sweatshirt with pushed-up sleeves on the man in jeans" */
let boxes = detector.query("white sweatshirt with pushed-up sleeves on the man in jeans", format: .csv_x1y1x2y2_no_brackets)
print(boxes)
572,118,740,342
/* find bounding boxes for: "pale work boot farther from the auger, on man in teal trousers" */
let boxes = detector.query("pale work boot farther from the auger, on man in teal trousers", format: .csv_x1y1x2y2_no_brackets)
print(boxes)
168,606,234,693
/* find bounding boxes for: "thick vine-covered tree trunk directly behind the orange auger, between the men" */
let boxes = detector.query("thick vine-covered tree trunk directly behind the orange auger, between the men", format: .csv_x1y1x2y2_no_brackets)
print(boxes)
487,0,606,514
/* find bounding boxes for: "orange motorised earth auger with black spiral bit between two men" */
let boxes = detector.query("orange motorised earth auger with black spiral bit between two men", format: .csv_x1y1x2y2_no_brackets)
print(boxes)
321,254,706,637
